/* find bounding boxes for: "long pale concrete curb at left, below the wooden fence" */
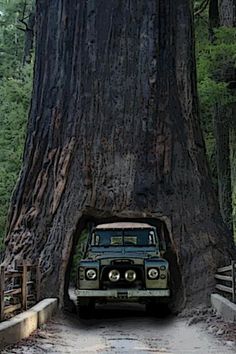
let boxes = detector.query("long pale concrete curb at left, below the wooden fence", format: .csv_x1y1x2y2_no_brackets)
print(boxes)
0,299,58,348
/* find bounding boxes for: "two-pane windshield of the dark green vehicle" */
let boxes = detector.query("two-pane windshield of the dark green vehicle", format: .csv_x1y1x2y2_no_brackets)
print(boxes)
92,229,157,247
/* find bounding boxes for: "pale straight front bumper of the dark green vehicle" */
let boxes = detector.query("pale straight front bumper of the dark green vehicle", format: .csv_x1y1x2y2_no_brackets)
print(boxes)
76,289,170,299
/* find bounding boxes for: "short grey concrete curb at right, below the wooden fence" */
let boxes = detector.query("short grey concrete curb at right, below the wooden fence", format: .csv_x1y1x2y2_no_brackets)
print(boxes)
211,294,236,322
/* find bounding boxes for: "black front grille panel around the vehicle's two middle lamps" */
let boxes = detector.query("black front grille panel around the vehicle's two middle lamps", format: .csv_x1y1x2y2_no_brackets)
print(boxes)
100,264,145,289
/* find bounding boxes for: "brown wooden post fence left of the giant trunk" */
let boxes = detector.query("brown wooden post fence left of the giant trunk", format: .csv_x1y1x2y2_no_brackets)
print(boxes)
0,261,40,321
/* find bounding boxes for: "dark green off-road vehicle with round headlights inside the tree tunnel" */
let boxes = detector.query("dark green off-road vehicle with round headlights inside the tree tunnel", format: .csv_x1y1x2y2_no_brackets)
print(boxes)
76,222,170,317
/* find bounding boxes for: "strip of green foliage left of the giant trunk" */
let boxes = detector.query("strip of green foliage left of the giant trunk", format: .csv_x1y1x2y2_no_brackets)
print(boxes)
0,0,33,250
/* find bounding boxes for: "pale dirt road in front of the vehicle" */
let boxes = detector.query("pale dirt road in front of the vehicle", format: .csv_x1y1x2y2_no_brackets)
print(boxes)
2,306,236,354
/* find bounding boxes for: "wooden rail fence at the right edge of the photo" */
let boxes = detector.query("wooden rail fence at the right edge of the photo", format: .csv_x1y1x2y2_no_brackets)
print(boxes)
215,261,236,303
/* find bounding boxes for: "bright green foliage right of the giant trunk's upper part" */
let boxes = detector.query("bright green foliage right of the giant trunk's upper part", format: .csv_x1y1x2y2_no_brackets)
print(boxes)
196,22,236,129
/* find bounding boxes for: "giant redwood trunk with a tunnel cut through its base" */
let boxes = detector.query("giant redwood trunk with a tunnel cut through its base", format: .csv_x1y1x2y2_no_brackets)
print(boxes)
5,0,234,308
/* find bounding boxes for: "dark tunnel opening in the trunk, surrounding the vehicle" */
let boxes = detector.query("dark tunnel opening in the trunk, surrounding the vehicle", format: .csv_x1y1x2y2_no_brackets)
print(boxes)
64,216,184,312
